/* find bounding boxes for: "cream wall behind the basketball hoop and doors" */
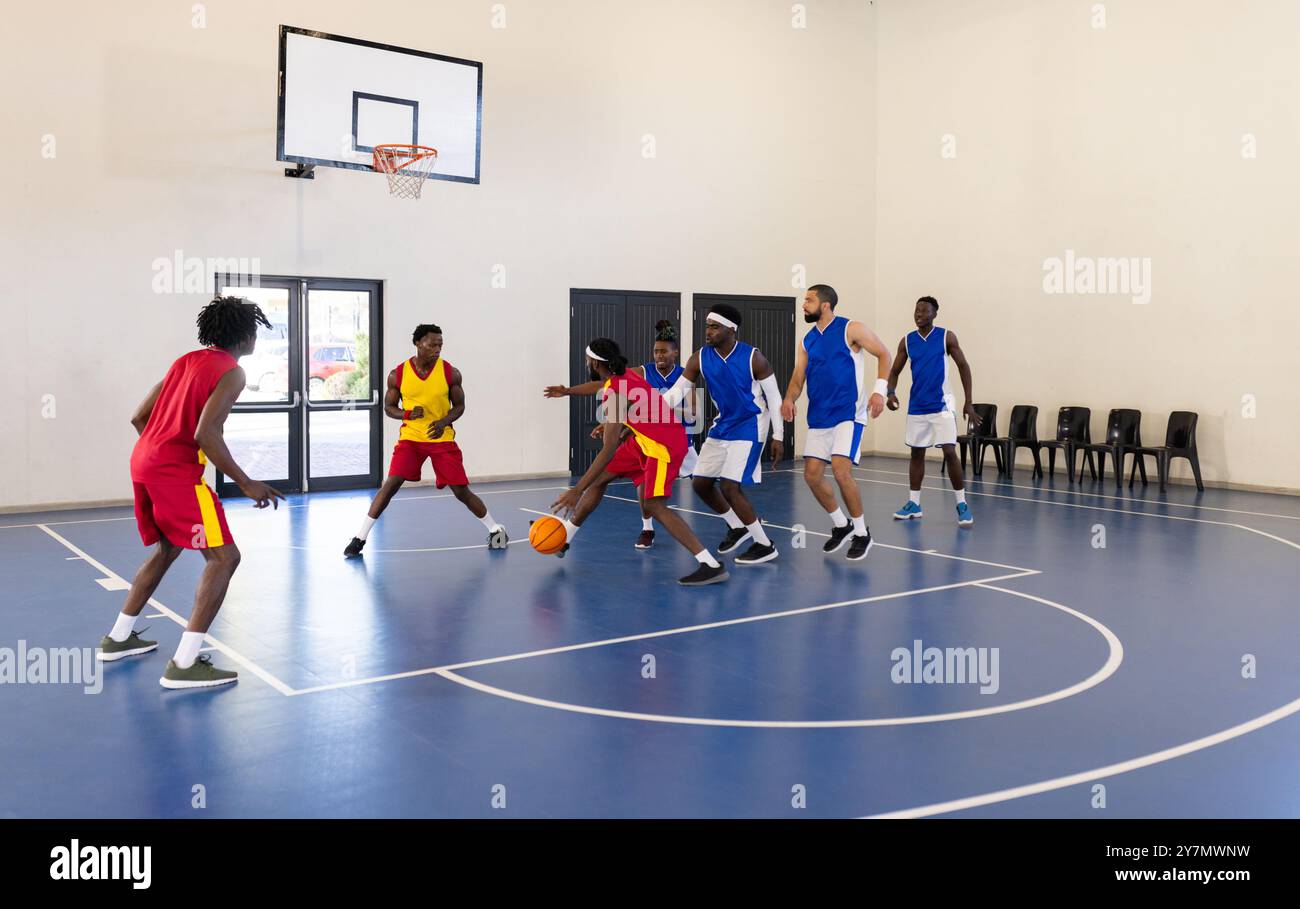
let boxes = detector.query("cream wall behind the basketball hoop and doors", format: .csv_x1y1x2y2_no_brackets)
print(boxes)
0,0,875,507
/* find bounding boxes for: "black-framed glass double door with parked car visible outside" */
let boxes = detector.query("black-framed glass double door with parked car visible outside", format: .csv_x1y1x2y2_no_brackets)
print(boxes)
216,274,384,497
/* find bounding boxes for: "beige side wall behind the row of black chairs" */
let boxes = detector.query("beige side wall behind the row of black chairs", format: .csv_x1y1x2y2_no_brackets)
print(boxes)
870,0,1300,489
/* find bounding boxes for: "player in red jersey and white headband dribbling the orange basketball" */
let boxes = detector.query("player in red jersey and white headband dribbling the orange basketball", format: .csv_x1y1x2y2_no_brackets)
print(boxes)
551,338,727,586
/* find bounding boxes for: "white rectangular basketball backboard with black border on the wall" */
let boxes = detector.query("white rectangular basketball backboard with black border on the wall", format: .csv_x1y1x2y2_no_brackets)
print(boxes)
277,25,484,183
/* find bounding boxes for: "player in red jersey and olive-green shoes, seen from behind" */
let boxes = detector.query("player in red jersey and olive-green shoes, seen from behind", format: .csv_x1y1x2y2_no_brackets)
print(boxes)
99,296,283,688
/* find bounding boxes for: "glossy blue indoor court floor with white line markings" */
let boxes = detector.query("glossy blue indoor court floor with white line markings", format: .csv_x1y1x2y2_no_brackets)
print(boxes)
0,458,1300,818
